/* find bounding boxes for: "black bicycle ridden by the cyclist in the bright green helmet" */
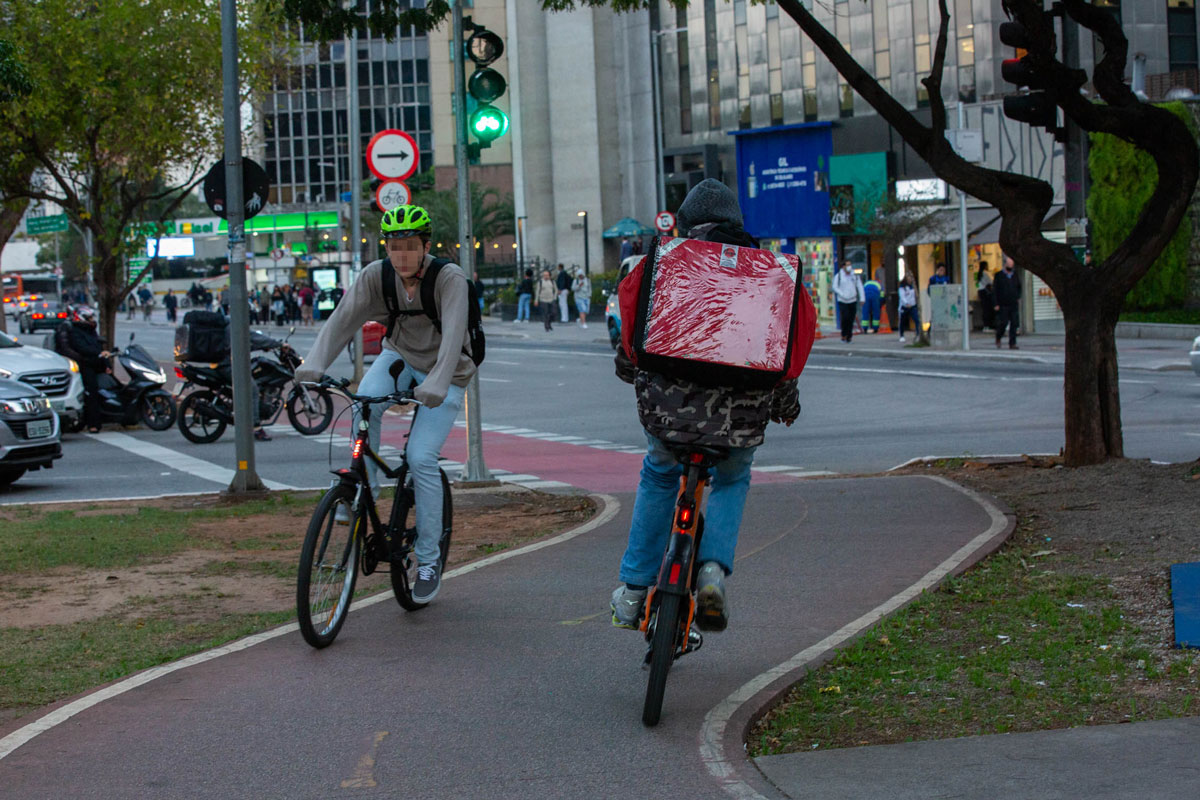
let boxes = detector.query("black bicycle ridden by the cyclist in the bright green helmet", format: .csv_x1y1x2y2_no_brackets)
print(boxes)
296,378,454,649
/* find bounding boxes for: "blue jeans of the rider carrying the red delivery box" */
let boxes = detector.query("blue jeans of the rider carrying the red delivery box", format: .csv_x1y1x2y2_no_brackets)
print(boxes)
620,433,756,587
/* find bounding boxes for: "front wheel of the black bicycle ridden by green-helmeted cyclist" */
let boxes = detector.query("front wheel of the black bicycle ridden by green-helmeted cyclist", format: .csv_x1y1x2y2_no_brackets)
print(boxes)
296,483,364,648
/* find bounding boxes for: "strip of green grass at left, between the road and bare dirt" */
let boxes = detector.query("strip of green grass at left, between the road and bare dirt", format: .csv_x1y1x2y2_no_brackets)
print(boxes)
0,493,312,575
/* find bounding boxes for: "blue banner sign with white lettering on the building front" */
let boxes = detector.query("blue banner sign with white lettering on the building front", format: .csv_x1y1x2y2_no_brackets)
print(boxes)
732,122,833,239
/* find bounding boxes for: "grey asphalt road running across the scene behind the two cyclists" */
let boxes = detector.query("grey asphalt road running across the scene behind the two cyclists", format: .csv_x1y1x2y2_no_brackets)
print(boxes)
0,321,1200,504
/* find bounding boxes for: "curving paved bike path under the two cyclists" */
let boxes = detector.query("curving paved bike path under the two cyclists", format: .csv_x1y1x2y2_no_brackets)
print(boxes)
0,477,996,800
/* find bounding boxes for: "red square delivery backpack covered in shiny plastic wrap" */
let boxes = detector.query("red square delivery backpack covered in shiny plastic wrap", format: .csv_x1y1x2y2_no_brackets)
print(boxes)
620,236,816,389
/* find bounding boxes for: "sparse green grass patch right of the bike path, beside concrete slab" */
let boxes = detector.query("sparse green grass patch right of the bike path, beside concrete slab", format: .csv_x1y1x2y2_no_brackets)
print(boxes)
748,542,1195,757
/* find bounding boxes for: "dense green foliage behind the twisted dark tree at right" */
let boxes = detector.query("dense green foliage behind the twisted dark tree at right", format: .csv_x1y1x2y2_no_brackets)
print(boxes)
1087,102,1192,311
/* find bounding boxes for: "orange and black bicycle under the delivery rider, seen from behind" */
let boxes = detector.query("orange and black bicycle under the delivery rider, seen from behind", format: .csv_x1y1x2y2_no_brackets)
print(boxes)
640,445,730,727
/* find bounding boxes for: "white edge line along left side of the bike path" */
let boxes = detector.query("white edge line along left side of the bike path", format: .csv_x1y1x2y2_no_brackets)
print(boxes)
0,494,620,759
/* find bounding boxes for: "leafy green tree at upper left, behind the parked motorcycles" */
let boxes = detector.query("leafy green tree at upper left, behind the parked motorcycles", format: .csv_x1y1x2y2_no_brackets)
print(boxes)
0,0,277,335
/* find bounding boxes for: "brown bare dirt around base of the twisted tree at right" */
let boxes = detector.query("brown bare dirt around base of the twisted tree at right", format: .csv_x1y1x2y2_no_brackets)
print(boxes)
905,458,1200,694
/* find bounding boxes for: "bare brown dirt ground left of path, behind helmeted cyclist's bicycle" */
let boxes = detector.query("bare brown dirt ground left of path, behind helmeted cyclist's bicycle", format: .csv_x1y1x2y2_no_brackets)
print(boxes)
0,488,595,628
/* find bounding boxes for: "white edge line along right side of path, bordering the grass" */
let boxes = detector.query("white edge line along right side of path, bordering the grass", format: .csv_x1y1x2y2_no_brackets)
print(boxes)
700,475,1008,800
